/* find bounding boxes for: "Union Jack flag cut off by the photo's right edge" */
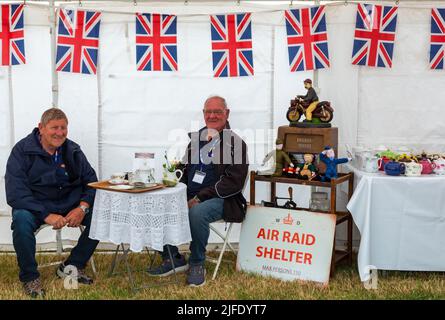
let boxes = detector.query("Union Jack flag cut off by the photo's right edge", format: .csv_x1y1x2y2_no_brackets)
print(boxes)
430,9,445,69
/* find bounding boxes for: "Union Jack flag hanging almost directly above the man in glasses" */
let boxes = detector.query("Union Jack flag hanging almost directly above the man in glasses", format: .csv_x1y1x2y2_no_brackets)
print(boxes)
210,13,253,77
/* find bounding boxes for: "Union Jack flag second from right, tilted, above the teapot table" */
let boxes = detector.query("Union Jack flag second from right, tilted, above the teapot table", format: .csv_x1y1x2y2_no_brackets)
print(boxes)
352,4,397,68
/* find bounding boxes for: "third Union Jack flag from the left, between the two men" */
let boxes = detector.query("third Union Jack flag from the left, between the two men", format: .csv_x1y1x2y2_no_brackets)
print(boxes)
136,13,178,71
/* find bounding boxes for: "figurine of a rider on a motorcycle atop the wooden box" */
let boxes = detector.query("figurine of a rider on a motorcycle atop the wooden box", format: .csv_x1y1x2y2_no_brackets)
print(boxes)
286,79,334,127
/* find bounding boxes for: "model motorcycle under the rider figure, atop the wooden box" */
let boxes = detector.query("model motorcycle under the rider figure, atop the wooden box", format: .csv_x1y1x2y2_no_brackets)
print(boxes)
286,96,334,123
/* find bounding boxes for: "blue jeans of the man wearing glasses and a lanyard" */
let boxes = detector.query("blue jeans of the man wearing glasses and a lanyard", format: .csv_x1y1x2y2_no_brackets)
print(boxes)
161,198,224,266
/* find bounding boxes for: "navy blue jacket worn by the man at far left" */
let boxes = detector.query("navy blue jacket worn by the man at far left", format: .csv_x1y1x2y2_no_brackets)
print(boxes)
5,128,97,221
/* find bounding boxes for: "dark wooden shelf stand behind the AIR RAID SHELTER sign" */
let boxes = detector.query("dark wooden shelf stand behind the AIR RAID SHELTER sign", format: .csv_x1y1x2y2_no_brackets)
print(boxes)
250,171,354,275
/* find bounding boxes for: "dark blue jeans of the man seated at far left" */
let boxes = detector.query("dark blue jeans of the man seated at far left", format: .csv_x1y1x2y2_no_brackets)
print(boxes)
11,208,99,282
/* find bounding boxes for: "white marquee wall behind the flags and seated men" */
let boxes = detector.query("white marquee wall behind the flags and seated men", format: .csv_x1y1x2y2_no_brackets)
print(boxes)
0,0,445,250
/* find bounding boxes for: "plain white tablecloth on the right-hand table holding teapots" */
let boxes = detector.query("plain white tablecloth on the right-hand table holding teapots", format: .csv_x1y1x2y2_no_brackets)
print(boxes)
347,166,445,281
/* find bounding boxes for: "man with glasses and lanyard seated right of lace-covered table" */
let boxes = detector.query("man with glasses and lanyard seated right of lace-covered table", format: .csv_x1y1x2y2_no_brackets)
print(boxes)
149,96,248,286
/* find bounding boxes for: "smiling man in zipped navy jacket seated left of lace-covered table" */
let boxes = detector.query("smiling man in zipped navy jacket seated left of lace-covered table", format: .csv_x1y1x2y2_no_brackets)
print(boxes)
5,108,99,297
